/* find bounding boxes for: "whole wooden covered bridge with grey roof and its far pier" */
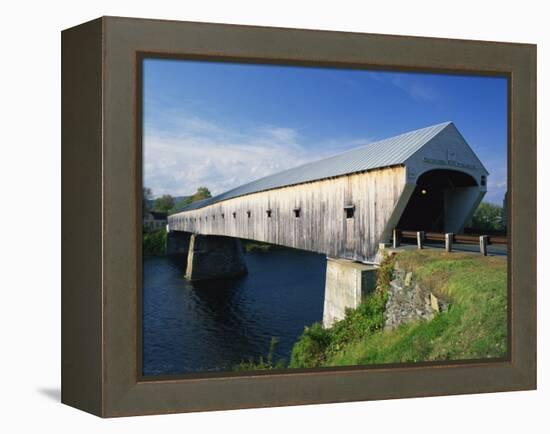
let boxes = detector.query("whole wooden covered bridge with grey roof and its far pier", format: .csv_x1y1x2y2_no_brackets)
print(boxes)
168,122,488,326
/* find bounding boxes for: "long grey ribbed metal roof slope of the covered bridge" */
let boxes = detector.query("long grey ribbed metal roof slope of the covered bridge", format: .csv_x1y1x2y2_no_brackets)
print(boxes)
180,122,452,211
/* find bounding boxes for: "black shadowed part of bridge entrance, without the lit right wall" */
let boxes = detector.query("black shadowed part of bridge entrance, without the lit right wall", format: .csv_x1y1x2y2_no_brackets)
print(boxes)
397,169,477,232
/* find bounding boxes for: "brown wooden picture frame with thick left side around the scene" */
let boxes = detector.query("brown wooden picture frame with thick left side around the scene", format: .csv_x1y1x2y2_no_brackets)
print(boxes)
62,17,537,417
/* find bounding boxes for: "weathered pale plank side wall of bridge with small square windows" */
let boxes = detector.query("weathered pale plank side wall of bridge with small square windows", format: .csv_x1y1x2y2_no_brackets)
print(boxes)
169,167,406,260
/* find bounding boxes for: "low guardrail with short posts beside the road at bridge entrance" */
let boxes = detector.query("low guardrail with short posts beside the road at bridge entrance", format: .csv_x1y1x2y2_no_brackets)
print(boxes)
393,229,508,256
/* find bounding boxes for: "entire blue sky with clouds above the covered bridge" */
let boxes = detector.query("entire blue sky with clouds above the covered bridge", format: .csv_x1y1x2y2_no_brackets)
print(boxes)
143,59,507,203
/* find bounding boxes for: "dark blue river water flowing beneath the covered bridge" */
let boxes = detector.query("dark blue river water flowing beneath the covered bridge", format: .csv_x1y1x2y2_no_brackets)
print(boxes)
143,249,326,376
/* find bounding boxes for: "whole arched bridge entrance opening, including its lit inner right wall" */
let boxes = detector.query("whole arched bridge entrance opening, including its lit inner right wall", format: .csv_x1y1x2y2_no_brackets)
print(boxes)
397,169,481,232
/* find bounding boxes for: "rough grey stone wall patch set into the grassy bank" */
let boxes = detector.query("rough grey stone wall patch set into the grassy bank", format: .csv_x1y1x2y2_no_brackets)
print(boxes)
384,262,448,330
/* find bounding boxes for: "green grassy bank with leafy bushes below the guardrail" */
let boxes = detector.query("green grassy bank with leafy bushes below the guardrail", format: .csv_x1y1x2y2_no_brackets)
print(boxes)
289,250,507,368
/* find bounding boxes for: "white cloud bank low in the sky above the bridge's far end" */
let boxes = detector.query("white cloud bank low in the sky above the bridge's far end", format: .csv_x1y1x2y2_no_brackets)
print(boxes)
143,114,365,196
